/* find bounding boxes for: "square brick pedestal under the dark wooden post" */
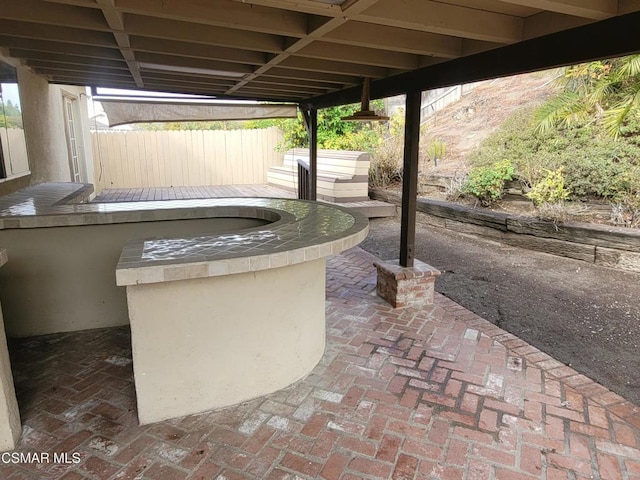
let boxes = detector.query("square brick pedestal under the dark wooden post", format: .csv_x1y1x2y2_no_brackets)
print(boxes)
373,260,440,308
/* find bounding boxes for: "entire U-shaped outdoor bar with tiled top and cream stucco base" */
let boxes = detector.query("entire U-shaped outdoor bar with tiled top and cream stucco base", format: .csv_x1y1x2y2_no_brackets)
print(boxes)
0,184,368,424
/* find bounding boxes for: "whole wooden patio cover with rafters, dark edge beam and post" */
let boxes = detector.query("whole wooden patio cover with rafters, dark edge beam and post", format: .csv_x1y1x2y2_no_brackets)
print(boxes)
0,0,640,265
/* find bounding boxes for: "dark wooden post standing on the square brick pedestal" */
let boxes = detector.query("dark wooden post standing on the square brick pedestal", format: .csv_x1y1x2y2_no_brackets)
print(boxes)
400,90,422,267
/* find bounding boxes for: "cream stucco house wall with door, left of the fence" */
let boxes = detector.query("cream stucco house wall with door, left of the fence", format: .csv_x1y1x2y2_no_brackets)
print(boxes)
17,66,93,184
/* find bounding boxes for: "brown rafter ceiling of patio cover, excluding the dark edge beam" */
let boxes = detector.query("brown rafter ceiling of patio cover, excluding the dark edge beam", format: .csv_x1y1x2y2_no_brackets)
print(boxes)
0,0,640,103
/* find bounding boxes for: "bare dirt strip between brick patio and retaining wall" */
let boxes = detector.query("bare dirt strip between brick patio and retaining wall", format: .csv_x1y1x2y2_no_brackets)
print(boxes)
361,213,640,405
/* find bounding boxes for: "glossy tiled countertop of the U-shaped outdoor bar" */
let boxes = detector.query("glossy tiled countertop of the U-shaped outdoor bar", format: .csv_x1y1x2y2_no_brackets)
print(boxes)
0,183,369,286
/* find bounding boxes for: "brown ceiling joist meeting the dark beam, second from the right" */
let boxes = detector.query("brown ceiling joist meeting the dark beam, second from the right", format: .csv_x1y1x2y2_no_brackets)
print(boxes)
354,0,523,43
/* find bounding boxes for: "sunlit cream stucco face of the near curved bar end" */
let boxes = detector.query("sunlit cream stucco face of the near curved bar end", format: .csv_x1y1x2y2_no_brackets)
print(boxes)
127,258,326,424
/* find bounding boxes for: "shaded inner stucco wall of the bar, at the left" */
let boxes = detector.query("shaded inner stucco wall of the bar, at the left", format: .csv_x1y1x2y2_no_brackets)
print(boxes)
0,218,265,337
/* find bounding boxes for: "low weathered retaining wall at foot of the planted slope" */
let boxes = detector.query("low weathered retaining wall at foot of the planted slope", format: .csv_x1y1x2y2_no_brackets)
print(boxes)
369,190,640,272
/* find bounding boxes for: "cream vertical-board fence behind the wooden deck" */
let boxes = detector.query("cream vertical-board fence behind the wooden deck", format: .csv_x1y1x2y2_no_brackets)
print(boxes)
91,127,284,192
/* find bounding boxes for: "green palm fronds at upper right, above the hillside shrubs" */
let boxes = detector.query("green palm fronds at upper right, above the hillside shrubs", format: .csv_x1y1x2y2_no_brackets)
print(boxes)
536,55,640,138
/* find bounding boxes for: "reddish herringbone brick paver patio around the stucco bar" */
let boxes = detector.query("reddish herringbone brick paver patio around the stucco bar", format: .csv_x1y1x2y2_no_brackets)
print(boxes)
0,248,640,480
